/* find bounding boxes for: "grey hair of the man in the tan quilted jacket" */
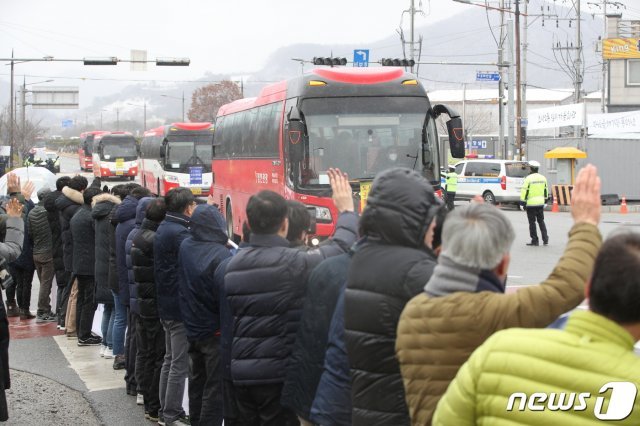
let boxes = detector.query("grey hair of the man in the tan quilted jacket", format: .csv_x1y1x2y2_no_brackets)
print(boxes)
442,203,515,269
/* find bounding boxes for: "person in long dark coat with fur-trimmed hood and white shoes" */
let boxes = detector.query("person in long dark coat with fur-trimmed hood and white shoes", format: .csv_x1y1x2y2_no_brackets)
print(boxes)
91,190,122,359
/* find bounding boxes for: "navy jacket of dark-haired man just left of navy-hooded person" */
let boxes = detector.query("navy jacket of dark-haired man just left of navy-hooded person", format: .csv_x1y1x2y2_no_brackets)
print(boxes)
153,212,190,321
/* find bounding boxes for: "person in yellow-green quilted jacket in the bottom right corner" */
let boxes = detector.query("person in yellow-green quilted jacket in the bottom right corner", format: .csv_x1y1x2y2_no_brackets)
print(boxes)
433,232,640,426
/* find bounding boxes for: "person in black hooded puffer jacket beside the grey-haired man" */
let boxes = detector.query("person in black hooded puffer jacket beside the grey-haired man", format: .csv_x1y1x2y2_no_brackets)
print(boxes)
344,168,439,426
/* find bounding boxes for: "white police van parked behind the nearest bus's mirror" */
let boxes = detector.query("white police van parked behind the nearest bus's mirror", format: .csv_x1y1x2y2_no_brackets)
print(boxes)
455,160,531,205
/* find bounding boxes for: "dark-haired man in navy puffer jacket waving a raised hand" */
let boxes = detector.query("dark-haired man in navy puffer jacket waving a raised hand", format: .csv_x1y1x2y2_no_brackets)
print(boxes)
224,169,358,425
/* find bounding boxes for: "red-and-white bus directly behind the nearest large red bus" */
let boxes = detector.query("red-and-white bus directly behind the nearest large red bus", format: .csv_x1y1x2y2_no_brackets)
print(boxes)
140,123,213,197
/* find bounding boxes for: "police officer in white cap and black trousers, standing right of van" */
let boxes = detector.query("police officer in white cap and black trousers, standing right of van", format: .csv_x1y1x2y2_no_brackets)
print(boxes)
520,161,549,246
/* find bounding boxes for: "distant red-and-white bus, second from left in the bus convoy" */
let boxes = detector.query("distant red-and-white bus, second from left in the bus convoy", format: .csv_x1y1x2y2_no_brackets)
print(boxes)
93,132,138,180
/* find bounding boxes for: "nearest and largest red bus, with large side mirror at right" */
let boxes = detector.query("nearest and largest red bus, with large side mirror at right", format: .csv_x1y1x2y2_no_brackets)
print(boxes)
212,67,464,243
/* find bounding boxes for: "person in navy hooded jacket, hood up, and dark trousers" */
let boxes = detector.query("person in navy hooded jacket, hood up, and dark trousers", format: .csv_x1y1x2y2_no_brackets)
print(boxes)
178,204,231,425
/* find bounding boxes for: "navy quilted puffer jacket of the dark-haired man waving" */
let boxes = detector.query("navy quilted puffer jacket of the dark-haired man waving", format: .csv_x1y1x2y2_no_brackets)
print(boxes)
224,213,358,386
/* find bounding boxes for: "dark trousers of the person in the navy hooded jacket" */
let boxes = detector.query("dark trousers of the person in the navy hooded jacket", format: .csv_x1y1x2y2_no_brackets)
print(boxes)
189,336,222,426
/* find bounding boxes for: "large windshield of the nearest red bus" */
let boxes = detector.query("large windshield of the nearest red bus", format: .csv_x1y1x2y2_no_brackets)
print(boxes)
300,97,438,186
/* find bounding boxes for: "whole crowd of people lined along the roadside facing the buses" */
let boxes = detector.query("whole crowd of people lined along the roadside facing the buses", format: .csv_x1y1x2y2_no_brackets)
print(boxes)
0,161,640,425
